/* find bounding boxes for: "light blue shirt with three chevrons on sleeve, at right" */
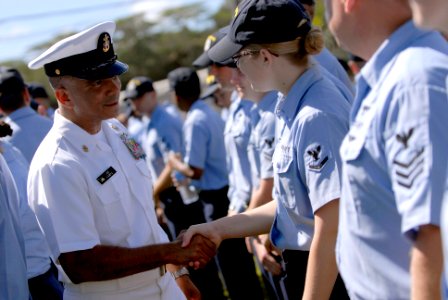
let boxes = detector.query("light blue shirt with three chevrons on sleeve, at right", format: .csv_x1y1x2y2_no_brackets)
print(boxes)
336,21,448,299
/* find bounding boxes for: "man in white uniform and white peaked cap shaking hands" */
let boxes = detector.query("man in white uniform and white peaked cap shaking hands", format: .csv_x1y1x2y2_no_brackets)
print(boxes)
28,22,215,300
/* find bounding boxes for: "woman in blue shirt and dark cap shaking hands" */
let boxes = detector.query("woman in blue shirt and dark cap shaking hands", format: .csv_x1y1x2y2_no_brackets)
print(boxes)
184,0,350,299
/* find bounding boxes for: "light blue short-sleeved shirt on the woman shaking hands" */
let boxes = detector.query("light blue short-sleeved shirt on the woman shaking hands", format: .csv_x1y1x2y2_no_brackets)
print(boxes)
271,66,350,251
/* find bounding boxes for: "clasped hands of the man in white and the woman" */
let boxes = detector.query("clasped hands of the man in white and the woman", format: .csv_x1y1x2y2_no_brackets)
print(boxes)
173,223,221,269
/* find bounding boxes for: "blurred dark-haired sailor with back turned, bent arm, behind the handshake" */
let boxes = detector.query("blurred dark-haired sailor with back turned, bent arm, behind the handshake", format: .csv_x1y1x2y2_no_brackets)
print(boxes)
168,68,263,299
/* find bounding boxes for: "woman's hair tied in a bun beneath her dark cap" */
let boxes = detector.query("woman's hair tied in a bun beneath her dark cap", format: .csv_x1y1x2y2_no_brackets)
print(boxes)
245,27,324,63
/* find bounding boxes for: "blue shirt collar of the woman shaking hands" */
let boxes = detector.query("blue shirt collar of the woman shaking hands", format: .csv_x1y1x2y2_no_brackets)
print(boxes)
275,65,322,122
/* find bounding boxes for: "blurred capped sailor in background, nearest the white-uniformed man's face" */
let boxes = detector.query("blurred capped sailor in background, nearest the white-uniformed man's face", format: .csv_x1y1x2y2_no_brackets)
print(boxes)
126,76,204,238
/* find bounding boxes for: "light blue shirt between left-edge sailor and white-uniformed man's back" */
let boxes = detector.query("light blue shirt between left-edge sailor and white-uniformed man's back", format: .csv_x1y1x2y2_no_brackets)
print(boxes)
0,141,50,279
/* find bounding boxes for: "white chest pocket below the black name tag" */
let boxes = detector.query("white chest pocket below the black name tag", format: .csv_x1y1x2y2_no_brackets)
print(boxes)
95,174,130,241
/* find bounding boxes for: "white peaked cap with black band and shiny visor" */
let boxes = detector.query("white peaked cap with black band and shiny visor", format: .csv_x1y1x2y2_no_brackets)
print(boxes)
28,22,128,80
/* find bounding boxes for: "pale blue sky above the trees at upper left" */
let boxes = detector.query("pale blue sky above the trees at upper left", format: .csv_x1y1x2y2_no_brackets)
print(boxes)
0,0,224,62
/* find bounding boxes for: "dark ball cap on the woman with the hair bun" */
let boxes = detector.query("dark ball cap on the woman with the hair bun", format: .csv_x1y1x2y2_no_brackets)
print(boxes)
208,0,311,62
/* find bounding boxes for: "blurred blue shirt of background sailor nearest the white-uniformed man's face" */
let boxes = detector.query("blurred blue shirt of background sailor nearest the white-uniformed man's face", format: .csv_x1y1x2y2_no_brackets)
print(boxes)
142,105,182,181
